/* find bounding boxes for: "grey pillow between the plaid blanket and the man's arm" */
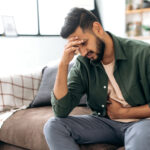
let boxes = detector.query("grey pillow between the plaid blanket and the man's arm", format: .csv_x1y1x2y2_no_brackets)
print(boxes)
29,62,86,108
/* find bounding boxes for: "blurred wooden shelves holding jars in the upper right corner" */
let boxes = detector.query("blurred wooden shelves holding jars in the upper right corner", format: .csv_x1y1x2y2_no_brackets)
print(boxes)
125,0,150,40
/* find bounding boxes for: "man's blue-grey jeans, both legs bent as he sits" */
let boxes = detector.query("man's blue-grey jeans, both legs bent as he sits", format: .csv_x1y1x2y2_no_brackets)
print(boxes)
44,115,150,150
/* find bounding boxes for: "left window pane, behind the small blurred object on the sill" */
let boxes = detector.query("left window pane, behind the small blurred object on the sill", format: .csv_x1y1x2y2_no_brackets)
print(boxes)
0,0,38,35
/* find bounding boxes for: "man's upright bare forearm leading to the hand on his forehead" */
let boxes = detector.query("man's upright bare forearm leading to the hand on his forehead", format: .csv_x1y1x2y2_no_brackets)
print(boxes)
54,62,68,100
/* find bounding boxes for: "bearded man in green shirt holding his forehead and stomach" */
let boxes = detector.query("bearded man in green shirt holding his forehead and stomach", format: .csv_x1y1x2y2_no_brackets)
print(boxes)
44,8,150,150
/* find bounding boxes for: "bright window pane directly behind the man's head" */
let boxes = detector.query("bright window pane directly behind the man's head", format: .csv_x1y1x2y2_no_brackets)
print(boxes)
39,0,94,35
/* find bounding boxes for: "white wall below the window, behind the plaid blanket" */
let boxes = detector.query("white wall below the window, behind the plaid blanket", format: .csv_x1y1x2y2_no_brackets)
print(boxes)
0,36,66,75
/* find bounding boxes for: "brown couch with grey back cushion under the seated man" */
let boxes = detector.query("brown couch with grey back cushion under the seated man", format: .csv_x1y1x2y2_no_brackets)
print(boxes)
0,60,124,150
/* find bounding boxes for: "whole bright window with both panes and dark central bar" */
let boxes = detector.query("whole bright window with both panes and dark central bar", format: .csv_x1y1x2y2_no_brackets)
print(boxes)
0,0,99,36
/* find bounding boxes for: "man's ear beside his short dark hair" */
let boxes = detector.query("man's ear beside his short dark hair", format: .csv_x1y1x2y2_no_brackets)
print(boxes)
92,21,103,36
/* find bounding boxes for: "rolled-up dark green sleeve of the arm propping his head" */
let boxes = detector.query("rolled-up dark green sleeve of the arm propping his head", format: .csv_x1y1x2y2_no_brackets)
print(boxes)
51,61,85,117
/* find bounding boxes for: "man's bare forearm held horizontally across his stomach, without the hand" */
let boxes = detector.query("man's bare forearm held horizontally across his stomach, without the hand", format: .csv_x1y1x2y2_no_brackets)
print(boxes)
121,104,150,119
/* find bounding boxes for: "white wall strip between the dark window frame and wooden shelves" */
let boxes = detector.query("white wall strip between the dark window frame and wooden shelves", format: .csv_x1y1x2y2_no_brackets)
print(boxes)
97,0,125,37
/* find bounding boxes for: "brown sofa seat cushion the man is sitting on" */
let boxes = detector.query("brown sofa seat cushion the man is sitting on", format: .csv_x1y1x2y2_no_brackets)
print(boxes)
0,106,123,150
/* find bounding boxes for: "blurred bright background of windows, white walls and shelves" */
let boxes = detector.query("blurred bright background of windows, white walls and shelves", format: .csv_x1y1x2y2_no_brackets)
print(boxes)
0,0,150,75
